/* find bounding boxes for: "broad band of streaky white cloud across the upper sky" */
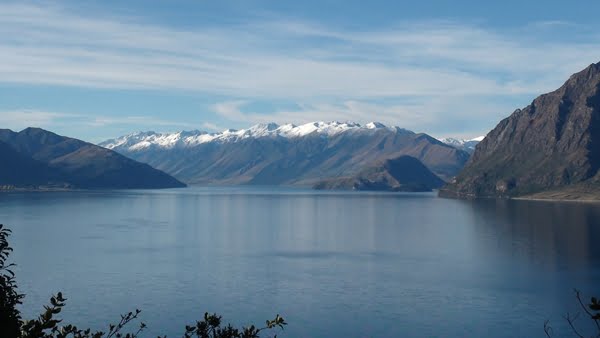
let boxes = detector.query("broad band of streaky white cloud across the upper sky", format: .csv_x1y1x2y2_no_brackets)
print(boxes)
0,4,600,99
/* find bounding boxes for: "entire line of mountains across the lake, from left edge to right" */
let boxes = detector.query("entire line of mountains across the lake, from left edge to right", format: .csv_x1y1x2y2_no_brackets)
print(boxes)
5,63,600,199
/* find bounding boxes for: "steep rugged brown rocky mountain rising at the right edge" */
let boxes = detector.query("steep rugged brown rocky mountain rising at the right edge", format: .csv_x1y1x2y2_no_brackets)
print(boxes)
440,64,600,199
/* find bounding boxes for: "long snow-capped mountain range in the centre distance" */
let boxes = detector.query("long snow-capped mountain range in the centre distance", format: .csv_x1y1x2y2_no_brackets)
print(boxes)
100,122,469,185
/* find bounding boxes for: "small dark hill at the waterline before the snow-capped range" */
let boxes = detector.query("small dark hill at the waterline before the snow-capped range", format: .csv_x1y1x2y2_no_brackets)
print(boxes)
314,155,445,192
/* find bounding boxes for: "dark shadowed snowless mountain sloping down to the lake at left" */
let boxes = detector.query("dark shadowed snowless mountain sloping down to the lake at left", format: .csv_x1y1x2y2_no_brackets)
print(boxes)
0,128,185,189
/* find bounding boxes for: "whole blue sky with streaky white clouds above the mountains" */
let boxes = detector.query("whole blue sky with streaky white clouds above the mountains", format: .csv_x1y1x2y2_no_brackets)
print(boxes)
0,0,600,142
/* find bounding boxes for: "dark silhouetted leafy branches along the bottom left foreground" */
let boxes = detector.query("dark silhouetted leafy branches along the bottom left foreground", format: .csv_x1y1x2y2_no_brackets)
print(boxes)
0,224,287,338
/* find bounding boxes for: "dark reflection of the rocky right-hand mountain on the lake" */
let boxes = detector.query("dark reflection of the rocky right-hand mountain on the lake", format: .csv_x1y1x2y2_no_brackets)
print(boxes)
467,200,600,269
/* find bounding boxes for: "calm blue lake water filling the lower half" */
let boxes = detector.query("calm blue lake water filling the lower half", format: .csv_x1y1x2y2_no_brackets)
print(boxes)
0,188,600,337
